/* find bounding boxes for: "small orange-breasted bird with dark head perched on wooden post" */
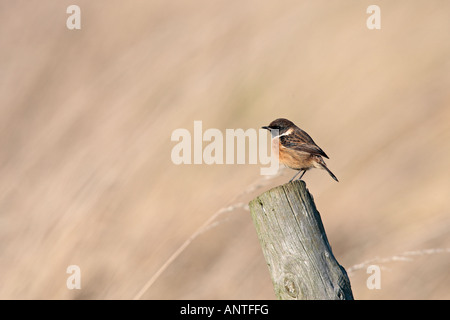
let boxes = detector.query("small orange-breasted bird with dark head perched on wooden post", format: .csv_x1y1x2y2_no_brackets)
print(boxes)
262,119,339,182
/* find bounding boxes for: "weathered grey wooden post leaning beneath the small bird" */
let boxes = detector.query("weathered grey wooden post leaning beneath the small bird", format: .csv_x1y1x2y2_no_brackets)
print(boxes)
249,180,353,300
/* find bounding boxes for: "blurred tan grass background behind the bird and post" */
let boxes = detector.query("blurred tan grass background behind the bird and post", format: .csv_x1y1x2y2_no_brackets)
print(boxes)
0,0,450,299
